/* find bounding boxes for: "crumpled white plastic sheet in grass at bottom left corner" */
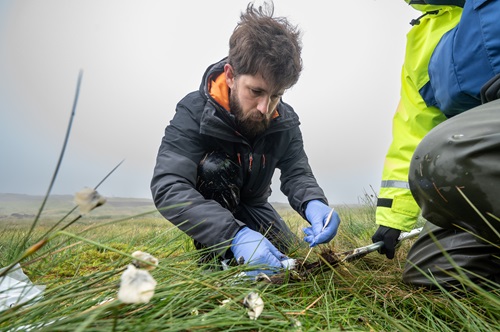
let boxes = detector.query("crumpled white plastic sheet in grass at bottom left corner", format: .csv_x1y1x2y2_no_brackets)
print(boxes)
0,264,45,311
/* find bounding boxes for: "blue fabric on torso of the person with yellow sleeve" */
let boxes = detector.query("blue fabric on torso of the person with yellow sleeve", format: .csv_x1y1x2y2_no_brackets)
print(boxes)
420,0,500,118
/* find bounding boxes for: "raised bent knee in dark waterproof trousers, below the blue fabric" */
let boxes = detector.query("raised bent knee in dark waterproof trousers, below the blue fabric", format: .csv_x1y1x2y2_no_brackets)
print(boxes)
409,100,500,244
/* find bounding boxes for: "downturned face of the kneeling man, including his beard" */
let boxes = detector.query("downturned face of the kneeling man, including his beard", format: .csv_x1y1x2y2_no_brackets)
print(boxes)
225,65,284,138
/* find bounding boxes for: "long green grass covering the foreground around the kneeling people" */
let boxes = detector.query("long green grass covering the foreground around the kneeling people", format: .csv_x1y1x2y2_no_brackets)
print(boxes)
0,200,500,331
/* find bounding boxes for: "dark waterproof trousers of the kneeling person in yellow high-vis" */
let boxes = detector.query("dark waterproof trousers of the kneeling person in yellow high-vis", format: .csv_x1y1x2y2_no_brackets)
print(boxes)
403,100,500,287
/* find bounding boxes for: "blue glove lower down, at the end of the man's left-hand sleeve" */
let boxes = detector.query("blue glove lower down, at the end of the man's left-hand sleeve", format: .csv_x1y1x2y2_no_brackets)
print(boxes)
231,227,288,274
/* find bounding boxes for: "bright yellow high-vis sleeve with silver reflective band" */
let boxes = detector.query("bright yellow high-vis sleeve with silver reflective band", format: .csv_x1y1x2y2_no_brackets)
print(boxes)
376,4,462,231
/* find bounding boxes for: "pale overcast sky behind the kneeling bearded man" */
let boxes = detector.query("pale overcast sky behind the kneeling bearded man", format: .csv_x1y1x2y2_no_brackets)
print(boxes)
0,0,419,204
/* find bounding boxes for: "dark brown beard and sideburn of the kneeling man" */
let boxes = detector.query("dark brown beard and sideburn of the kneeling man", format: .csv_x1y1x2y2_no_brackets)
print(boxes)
229,94,271,139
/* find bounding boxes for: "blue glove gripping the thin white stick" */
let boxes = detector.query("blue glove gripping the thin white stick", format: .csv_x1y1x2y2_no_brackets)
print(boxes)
303,200,340,247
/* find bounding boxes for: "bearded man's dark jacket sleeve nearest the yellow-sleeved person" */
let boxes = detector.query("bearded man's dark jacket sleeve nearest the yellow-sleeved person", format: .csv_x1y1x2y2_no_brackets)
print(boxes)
278,127,328,219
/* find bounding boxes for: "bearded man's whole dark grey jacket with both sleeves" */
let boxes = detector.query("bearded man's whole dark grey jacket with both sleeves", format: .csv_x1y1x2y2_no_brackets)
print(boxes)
151,59,327,252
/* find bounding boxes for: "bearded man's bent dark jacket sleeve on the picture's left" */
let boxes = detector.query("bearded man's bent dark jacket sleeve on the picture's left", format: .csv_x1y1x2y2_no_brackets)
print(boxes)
151,97,244,254
